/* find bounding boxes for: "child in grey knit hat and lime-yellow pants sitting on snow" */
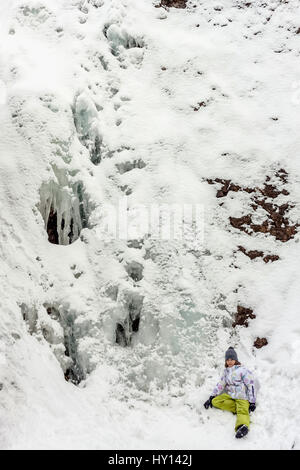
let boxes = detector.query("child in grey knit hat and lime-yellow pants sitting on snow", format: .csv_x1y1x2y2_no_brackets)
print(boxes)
204,347,256,439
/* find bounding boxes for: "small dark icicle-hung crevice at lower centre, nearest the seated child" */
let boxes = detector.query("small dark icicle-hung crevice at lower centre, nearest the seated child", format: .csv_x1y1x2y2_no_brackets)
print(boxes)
116,292,144,347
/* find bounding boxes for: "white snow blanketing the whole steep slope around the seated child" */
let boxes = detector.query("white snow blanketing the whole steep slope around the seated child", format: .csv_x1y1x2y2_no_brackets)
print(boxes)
0,0,300,449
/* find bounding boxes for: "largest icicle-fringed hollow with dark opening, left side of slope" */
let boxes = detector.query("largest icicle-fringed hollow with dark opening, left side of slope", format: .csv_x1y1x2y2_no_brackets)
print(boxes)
38,173,91,245
